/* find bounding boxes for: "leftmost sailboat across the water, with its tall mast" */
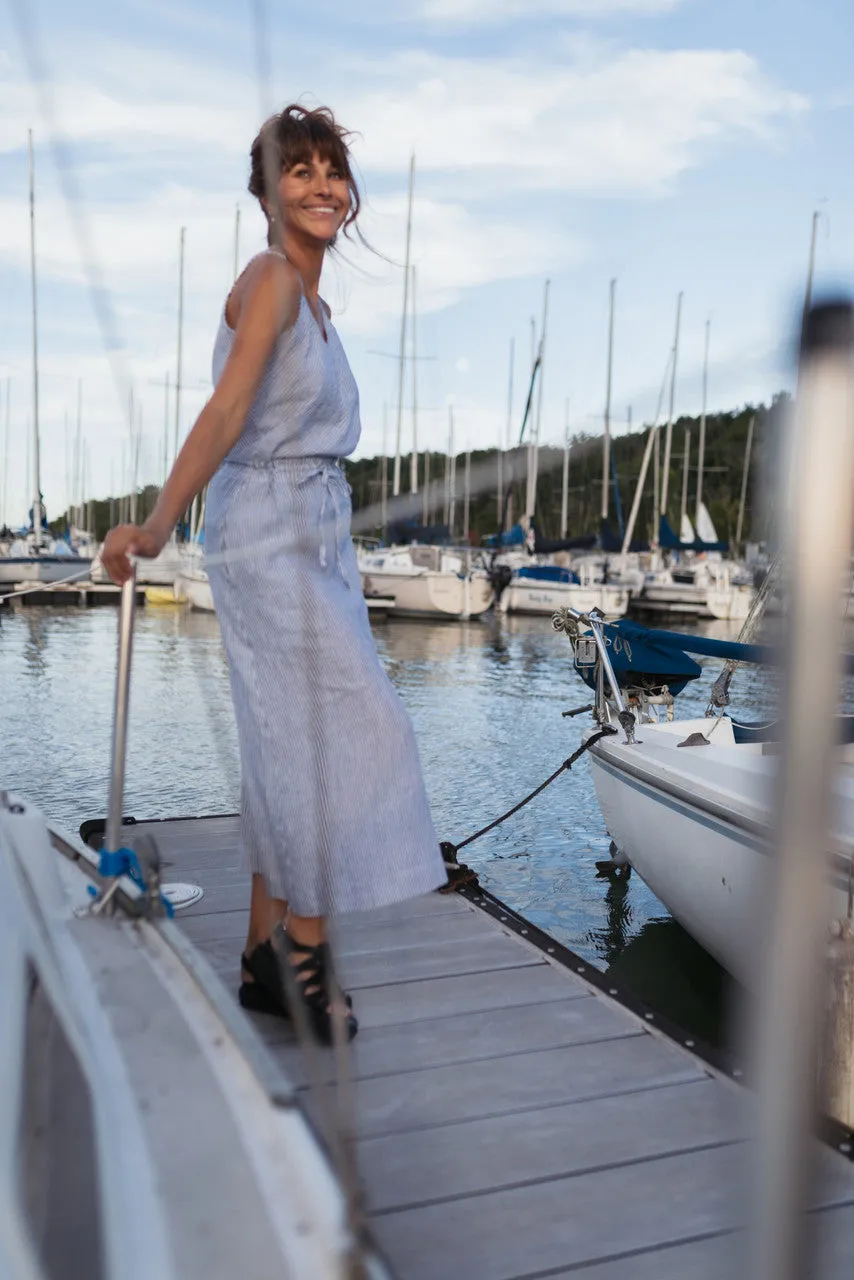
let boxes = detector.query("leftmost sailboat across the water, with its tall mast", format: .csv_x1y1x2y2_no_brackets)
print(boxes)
0,129,92,593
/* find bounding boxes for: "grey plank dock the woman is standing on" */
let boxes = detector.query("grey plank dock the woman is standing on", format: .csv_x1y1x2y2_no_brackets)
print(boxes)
101,817,854,1280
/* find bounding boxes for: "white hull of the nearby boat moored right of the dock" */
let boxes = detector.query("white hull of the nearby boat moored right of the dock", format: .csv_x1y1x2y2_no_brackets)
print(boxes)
590,719,854,986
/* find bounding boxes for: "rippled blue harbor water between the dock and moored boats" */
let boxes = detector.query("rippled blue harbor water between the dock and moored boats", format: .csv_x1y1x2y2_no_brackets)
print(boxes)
0,607,767,1038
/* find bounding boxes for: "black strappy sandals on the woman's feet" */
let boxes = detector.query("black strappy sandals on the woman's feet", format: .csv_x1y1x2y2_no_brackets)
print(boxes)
238,925,359,1044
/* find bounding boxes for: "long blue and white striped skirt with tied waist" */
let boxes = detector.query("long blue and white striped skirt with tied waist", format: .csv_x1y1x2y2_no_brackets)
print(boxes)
205,458,446,915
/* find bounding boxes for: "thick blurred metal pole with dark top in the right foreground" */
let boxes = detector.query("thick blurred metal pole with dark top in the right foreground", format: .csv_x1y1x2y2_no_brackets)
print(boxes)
746,302,854,1280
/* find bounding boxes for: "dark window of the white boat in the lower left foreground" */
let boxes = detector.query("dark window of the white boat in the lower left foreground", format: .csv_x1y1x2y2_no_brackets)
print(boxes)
19,966,105,1280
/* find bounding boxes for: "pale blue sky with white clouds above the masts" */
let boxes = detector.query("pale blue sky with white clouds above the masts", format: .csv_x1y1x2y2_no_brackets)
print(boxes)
0,0,854,522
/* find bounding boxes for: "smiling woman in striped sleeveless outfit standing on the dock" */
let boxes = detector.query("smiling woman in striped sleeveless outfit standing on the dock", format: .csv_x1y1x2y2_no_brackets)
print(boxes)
102,106,446,1043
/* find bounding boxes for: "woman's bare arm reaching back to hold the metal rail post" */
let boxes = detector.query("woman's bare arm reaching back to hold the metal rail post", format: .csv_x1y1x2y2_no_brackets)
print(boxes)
101,256,302,582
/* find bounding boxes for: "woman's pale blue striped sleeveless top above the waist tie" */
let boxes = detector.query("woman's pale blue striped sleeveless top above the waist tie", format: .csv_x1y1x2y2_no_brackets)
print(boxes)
213,250,361,466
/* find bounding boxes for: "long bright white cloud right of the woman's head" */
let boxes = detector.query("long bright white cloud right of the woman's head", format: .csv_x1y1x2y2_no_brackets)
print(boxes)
347,50,808,196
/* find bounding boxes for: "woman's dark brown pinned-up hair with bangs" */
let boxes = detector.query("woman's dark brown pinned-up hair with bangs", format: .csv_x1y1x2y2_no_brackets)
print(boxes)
248,102,361,232
